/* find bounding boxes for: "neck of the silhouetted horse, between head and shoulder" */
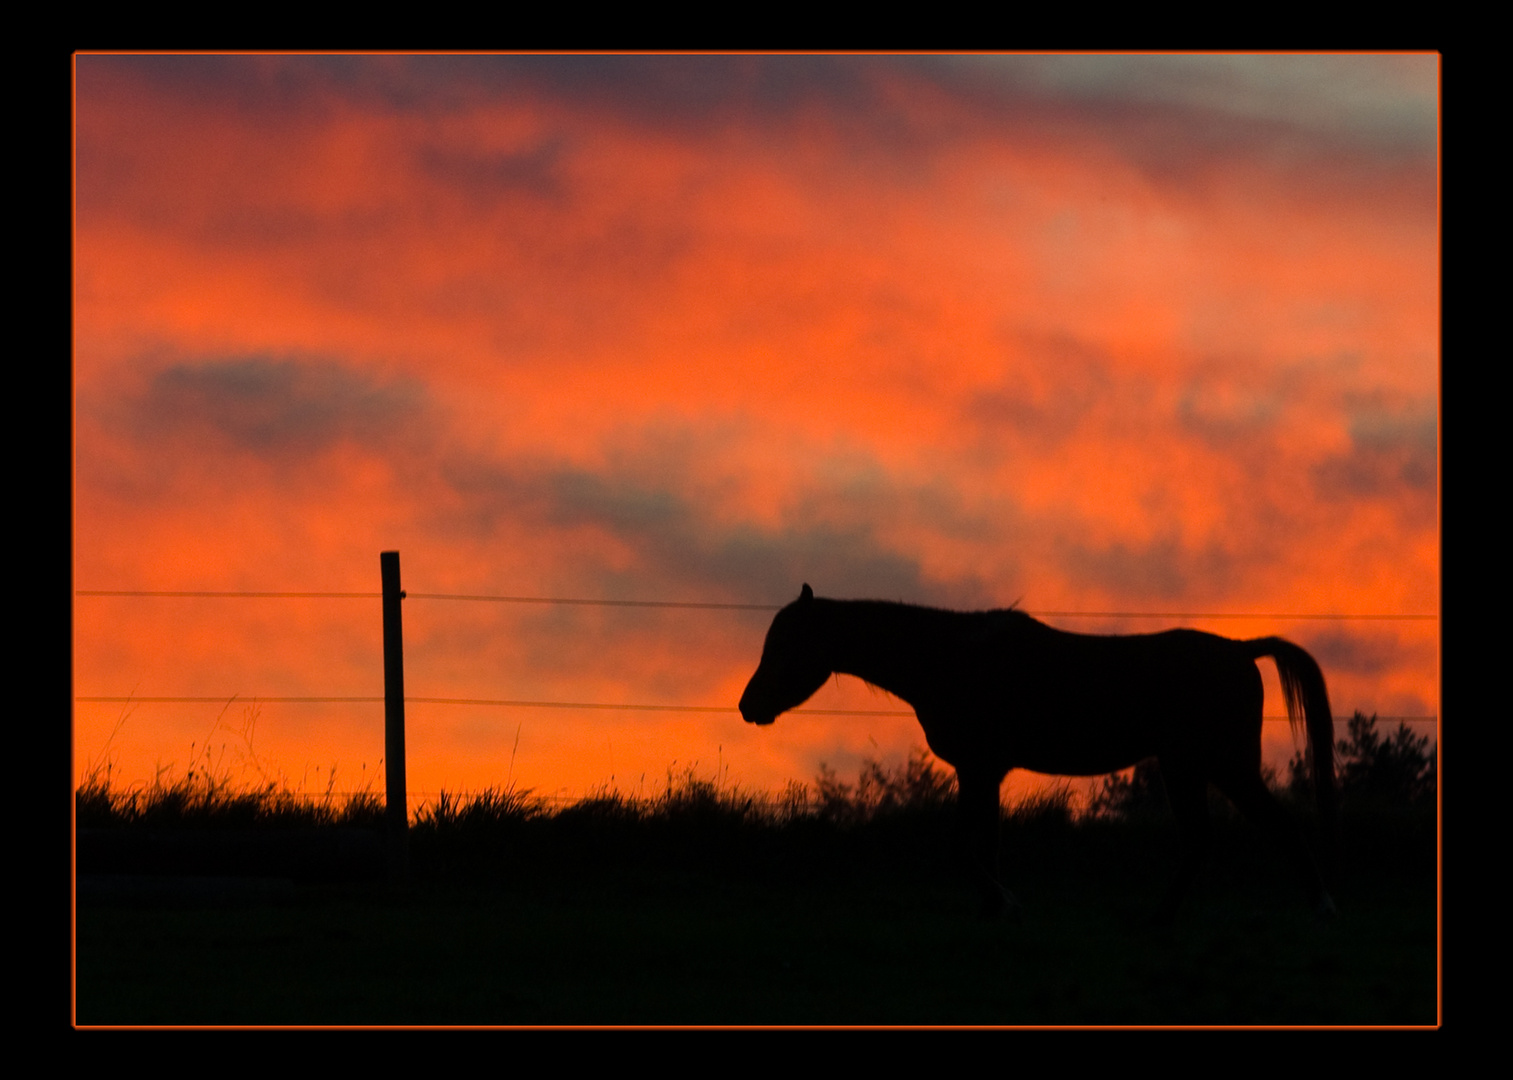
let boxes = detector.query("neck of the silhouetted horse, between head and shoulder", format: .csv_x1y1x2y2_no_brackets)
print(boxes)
816,601,949,705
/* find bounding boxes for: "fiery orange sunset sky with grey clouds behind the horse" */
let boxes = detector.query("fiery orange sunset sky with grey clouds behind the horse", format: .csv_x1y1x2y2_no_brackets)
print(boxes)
73,54,1440,797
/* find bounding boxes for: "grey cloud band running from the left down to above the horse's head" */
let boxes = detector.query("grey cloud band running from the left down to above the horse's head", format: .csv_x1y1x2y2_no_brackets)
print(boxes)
100,357,991,607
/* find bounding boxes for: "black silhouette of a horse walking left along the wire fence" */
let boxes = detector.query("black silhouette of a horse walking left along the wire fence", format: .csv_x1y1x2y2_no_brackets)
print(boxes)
740,585,1334,920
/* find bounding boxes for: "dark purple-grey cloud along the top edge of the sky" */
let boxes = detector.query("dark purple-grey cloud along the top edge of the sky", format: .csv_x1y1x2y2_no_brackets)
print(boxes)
79,56,1439,213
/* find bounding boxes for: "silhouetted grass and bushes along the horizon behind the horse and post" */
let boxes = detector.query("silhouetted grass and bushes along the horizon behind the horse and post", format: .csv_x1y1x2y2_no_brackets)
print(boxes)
76,711,1436,853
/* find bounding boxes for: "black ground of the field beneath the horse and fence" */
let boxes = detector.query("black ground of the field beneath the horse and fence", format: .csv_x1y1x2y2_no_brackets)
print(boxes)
76,750,1439,1026
